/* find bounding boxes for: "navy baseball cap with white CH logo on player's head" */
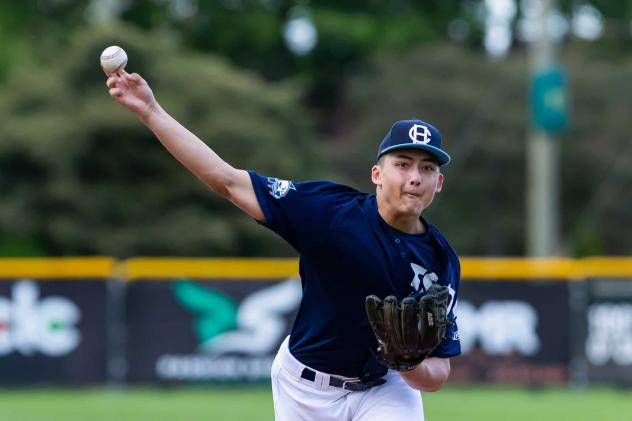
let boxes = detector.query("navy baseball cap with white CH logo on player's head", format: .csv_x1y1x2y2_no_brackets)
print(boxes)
377,120,450,165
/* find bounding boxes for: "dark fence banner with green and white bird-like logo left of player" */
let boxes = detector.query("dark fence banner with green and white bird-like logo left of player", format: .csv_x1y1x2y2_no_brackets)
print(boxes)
125,278,301,383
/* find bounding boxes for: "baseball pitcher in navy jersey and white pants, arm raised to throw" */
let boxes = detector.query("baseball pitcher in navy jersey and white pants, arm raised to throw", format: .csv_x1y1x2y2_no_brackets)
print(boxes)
107,71,460,421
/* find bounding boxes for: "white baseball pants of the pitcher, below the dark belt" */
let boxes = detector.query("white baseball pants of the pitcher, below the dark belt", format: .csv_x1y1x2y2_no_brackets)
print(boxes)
272,336,424,421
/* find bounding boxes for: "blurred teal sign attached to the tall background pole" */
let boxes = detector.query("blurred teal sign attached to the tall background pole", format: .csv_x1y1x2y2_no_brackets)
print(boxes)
531,68,568,133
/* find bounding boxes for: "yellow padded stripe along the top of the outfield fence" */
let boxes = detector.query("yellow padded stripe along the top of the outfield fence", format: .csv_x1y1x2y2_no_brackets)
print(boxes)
0,257,632,281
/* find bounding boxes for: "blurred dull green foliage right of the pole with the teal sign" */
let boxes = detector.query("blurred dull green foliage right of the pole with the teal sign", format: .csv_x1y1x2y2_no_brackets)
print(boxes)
561,49,632,255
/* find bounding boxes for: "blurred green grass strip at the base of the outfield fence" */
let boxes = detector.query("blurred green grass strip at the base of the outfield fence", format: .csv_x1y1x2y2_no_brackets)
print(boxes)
0,387,632,421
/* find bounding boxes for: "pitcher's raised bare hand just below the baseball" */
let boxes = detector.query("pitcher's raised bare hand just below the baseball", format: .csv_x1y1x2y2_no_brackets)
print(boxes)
106,70,159,120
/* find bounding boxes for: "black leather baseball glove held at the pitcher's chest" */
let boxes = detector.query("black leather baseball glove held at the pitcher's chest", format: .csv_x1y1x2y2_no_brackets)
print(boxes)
365,284,450,371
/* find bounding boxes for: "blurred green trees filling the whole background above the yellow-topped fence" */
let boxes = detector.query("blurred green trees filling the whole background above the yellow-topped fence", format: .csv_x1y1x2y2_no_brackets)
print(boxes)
0,0,632,256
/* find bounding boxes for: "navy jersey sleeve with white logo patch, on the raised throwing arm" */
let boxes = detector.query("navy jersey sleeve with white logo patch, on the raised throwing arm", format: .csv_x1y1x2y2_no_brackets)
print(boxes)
249,171,359,252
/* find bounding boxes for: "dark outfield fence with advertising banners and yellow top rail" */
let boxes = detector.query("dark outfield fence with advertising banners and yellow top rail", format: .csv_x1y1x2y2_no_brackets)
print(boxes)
0,257,632,386
